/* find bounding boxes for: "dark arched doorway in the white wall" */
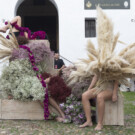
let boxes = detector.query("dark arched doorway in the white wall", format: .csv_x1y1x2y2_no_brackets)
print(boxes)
17,0,59,52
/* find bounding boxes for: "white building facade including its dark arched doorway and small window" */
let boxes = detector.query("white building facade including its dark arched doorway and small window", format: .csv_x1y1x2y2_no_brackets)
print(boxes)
0,0,135,64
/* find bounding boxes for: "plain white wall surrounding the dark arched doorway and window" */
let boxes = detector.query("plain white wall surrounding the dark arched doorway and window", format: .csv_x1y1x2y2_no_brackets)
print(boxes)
0,0,135,64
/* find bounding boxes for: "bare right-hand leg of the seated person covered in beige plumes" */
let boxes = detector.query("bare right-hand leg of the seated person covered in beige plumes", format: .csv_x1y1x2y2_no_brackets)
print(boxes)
95,90,112,130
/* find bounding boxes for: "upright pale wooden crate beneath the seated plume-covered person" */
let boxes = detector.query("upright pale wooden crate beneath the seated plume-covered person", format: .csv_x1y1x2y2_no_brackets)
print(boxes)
97,94,124,125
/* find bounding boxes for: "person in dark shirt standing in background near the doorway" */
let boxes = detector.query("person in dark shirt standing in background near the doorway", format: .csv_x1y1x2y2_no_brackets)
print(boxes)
54,53,65,71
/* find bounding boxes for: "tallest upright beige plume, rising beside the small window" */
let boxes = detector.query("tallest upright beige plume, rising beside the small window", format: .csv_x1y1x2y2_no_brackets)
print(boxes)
97,6,113,63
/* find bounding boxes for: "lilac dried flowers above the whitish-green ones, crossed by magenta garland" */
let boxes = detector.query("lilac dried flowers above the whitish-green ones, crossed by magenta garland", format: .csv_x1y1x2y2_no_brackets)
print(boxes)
11,42,54,72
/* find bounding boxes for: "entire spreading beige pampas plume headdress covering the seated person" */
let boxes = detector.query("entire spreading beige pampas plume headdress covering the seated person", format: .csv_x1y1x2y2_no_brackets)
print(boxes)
69,7,135,90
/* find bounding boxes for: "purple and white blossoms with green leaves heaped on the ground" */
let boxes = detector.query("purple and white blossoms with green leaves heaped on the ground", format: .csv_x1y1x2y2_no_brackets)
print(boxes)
60,94,86,124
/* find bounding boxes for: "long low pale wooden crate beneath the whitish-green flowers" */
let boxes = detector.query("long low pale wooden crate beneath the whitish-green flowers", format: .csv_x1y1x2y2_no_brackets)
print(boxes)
0,99,59,120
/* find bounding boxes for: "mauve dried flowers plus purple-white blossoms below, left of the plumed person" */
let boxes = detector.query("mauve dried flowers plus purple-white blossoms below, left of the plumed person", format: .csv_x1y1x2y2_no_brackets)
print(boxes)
60,66,91,124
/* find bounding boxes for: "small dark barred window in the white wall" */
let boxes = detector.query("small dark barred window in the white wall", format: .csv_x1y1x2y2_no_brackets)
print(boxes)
85,18,96,37
